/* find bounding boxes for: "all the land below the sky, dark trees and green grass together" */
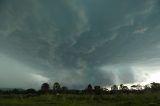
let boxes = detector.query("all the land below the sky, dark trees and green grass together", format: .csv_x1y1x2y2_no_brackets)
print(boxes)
0,82,160,106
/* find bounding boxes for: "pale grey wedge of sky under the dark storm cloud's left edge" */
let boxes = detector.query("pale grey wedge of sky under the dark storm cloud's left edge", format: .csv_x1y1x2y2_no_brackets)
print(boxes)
0,54,49,89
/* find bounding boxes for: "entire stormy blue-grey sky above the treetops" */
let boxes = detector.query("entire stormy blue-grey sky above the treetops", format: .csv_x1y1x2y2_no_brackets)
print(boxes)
0,0,160,89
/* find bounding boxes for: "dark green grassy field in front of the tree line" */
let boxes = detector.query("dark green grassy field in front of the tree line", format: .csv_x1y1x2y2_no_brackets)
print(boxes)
0,92,160,106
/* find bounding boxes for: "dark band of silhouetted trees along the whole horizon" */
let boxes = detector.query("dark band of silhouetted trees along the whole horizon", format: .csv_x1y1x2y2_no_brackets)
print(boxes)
0,82,160,96
